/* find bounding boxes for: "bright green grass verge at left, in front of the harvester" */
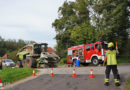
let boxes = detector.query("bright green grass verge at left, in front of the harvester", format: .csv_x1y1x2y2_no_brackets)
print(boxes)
0,68,37,83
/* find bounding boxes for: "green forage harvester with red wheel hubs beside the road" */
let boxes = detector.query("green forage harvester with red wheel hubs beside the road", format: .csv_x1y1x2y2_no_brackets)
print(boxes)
16,43,60,68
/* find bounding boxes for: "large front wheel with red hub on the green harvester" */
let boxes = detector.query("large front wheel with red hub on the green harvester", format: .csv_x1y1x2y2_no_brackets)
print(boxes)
25,57,37,68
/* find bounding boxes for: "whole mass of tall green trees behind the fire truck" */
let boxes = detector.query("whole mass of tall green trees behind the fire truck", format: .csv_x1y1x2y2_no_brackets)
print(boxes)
52,0,130,57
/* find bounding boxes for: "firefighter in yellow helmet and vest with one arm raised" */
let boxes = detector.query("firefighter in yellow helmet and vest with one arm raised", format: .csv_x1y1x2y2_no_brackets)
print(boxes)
103,42,120,86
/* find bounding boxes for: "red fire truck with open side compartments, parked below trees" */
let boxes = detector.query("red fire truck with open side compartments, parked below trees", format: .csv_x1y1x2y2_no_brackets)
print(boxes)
67,41,108,66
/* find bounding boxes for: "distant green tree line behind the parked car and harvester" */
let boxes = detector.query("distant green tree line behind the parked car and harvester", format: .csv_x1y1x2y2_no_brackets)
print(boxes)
0,37,34,62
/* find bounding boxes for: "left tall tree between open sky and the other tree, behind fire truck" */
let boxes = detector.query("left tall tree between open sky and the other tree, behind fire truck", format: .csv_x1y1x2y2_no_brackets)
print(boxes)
52,0,93,57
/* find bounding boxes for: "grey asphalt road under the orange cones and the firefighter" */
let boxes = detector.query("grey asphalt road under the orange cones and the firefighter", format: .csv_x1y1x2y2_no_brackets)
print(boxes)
8,66,130,90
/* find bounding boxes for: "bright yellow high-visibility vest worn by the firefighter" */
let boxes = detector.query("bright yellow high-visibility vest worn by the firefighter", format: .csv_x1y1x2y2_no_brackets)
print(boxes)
106,50,117,65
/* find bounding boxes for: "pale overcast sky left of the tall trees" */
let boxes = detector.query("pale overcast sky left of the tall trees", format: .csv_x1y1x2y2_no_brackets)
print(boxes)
0,0,75,47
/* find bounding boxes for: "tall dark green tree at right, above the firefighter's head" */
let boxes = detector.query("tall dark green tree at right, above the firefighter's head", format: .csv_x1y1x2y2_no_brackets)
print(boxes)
91,0,130,47
